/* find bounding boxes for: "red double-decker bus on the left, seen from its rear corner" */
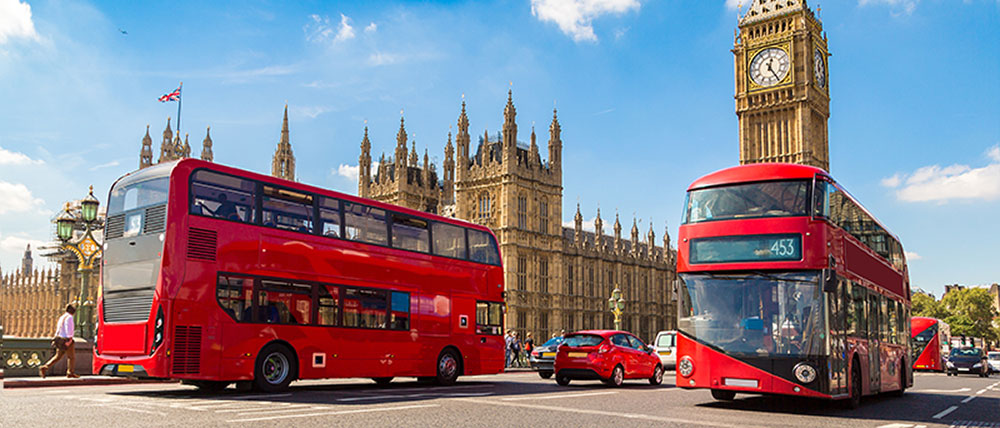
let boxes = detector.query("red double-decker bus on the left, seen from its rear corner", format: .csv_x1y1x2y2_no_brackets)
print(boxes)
94,159,504,391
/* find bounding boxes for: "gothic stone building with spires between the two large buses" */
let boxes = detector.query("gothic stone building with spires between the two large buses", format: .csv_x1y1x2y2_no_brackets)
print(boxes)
358,93,676,341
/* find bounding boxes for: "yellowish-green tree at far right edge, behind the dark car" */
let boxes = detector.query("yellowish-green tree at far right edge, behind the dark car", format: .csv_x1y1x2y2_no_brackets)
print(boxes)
941,288,996,338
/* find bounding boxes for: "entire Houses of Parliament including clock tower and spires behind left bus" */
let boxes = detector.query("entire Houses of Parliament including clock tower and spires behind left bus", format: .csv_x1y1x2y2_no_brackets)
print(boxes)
0,0,830,341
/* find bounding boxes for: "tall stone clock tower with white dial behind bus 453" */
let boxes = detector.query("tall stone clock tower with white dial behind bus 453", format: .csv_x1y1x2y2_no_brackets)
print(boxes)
733,0,830,171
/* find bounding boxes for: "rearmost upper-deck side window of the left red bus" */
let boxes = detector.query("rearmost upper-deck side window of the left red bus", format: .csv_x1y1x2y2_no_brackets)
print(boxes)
191,170,257,223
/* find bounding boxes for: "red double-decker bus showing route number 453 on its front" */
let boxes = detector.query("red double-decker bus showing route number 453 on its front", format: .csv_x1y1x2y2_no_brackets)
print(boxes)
677,163,913,407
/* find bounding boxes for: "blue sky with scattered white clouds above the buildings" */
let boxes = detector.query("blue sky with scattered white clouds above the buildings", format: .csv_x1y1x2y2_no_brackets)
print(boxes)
0,0,1000,296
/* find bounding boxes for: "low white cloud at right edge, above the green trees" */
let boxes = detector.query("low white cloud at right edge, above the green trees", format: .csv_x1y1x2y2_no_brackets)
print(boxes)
882,144,1000,203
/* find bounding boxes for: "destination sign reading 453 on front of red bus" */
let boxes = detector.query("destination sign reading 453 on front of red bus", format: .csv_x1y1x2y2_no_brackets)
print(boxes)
689,234,802,263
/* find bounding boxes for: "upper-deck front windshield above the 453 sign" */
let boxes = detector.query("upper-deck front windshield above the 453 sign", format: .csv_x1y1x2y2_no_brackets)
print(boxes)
682,180,809,224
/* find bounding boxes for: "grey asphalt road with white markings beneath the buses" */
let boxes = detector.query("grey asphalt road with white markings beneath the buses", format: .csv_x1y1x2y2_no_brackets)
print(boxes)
0,372,1000,428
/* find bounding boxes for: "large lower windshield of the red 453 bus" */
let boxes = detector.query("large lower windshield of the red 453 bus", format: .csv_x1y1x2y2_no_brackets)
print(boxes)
678,272,826,356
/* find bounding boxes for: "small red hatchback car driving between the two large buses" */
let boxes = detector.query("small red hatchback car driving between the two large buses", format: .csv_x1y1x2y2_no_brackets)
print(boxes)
555,330,663,386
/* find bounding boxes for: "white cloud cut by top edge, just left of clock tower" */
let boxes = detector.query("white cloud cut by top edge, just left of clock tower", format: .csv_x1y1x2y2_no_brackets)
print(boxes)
531,0,639,42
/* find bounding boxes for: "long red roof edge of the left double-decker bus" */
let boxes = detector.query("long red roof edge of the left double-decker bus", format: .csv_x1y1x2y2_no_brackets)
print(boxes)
165,158,496,239
